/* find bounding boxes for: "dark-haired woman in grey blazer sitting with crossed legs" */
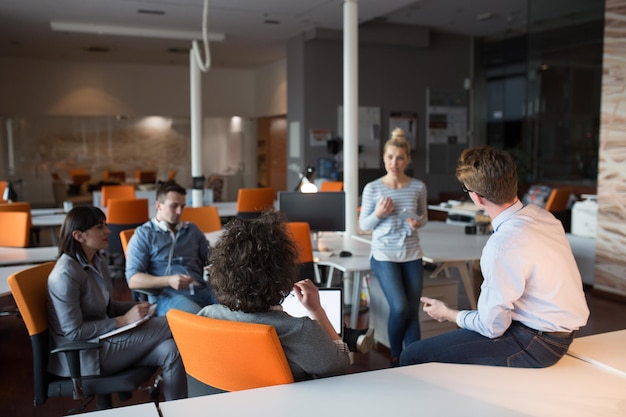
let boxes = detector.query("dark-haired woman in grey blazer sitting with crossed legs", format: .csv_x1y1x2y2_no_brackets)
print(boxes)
48,206,187,400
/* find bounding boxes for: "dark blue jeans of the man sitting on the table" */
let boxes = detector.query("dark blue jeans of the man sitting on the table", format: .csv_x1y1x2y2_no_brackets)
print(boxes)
400,321,573,368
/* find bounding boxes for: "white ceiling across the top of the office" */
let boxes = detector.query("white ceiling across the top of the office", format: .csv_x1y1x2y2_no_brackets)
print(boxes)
0,0,527,68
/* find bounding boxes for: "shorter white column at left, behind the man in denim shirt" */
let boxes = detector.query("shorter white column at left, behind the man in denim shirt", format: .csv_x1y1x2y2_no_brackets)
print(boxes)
189,49,204,207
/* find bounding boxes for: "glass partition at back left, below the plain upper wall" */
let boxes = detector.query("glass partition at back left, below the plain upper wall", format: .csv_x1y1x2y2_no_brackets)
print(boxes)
0,115,247,206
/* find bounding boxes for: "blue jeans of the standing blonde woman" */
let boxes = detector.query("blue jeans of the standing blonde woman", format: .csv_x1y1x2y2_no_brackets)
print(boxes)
370,258,423,358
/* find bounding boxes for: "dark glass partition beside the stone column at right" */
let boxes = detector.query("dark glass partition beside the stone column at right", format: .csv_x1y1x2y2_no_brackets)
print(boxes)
477,0,604,189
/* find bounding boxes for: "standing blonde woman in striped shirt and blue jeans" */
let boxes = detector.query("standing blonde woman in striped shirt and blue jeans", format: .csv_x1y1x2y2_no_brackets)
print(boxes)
359,128,428,366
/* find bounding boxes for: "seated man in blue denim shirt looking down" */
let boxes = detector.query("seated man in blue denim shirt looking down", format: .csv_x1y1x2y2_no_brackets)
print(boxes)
126,181,216,316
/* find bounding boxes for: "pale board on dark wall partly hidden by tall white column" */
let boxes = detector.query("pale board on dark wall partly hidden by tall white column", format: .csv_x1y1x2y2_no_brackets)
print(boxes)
337,106,381,168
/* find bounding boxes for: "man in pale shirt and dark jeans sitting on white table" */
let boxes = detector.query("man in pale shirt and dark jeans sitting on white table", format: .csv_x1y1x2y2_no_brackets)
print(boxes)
400,146,589,368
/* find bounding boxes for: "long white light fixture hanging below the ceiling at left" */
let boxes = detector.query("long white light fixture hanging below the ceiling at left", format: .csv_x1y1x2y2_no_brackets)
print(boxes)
50,21,226,42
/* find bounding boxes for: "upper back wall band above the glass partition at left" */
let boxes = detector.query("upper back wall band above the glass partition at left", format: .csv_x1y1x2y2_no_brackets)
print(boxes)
0,59,260,117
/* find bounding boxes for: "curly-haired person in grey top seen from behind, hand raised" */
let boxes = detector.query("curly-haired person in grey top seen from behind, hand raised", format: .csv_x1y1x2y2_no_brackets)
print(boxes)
198,212,350,381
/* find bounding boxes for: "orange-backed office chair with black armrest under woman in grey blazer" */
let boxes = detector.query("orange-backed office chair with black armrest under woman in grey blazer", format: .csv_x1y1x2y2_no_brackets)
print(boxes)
8,262,161,411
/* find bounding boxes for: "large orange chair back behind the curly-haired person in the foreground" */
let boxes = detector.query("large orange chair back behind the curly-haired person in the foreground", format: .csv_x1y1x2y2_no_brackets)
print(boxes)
167,309,294,397
